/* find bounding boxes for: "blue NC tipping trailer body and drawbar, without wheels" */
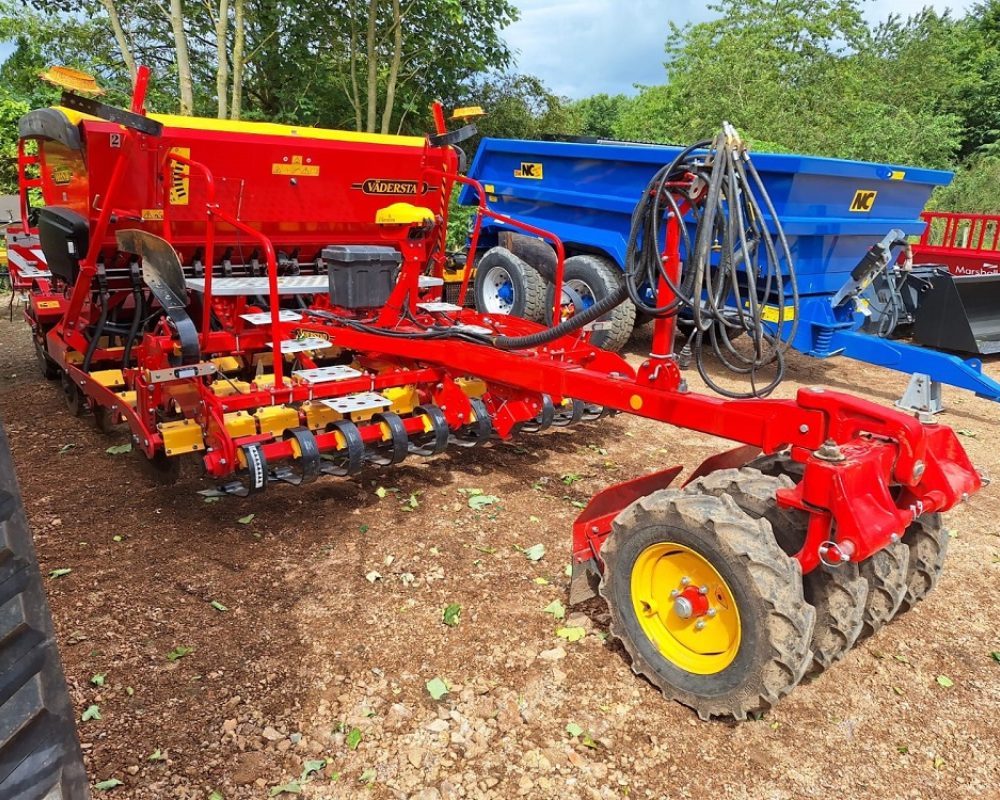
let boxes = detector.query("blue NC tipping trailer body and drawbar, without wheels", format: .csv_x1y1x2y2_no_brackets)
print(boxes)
460,138,1000,401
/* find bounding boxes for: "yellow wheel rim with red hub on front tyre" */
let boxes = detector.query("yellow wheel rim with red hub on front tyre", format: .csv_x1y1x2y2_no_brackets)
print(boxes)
632,542,740,675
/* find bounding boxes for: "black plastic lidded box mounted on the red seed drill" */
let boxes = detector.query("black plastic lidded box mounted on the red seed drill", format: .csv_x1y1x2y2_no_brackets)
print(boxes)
323,244,403,308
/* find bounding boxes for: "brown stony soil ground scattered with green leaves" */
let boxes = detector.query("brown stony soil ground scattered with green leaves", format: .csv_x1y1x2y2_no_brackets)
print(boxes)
0,300,1000,800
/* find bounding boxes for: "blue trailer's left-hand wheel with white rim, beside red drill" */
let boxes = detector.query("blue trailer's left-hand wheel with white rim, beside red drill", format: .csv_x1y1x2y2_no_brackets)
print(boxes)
473,247,545,322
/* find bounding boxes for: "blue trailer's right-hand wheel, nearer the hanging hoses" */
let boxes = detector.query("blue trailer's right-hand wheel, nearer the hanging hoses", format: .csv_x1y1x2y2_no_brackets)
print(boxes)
545,255,635,353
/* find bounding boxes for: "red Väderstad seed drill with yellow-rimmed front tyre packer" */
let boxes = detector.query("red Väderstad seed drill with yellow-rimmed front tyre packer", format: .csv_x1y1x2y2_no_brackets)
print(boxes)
8,70,980,718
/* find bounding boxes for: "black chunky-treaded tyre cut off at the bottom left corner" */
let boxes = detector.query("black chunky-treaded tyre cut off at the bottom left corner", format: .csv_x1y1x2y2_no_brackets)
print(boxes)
0,426,88,800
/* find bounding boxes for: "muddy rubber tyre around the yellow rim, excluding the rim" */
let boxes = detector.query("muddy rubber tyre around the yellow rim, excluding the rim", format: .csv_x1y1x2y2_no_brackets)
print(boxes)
600,489,815,720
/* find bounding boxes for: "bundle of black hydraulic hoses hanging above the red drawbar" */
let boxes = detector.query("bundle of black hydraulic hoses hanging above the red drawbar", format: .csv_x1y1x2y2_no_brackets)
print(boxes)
493,123,798,398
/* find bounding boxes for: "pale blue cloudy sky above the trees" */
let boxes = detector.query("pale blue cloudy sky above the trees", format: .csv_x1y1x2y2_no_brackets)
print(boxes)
505,0,972,98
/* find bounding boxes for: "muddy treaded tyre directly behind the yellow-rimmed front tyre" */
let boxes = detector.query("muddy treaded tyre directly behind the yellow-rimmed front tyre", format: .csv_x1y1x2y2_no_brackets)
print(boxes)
687,467,868,674
